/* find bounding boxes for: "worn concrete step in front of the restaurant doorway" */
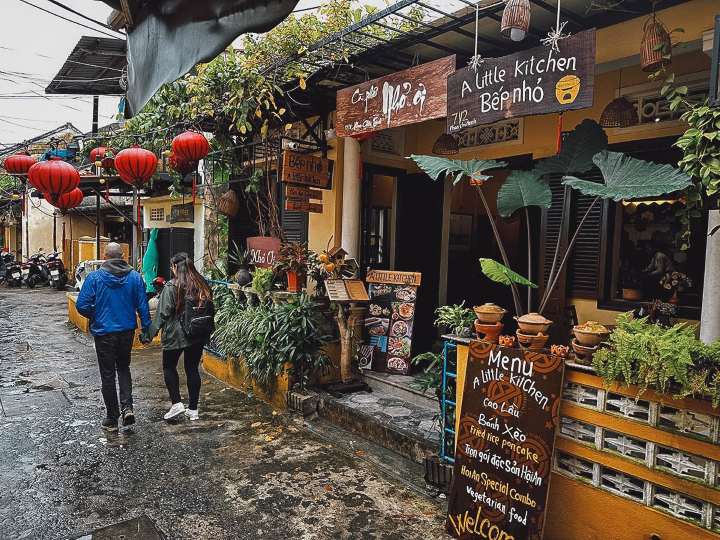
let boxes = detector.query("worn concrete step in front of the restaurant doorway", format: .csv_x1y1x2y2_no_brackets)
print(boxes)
318,390,440,463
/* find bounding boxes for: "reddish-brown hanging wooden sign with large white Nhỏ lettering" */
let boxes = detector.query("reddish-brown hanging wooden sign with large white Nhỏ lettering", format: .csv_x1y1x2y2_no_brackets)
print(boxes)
335,55,455,137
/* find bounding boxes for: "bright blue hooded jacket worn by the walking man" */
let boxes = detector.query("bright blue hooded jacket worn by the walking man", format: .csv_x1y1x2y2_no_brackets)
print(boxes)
76,259,151,336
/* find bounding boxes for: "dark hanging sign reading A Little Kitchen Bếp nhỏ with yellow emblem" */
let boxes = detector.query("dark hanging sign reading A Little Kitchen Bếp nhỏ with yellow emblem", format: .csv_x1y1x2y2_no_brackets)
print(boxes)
447,28,595,133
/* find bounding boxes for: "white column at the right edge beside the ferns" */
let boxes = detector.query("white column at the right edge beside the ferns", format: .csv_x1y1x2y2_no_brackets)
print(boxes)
700,210,720,343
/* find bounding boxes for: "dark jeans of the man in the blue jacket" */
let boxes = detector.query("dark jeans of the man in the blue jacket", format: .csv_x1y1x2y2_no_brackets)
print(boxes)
95,330,135,420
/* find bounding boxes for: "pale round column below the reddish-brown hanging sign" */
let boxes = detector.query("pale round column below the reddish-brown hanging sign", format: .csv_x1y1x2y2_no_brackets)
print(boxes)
342,137,362,258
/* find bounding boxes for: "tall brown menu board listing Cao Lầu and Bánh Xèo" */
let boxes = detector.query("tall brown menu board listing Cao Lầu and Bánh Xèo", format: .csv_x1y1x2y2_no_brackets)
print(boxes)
446,340,565,540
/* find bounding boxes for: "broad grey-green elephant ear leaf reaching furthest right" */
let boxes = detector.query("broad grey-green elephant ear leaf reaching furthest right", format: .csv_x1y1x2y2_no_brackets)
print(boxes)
563,150,690,201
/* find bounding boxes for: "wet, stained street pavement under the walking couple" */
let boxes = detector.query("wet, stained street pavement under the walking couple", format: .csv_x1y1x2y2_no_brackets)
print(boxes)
0,288,447,540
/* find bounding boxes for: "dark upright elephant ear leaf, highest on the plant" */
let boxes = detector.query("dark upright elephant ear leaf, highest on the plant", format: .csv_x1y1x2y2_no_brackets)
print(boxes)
536,119,608,175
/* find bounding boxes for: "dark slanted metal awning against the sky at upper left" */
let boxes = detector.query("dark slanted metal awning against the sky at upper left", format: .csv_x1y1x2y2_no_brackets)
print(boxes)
45,36,127,96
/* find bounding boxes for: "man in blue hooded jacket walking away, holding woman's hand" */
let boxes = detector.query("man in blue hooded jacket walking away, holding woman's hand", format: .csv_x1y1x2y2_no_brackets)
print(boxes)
76,242,151,431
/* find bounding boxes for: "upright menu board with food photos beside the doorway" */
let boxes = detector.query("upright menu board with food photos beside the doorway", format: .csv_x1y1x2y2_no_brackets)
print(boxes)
361,270,421,375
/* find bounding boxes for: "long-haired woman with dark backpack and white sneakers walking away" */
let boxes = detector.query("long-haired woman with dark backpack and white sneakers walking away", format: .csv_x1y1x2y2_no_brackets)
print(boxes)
146,253,214,420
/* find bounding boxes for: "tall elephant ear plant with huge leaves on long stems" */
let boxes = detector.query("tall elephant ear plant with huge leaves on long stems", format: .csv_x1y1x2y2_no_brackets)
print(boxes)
410,120,690,315
